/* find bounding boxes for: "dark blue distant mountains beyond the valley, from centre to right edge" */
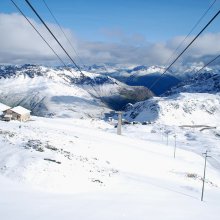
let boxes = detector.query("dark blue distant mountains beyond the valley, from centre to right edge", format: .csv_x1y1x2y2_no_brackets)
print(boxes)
84,63,220,95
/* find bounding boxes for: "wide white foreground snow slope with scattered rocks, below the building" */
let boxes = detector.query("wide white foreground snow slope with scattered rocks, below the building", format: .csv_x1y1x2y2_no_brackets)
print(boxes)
0,117,220,220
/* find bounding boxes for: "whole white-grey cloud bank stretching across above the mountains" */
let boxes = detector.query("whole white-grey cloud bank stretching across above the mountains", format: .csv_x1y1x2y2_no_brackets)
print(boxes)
0,14,220,65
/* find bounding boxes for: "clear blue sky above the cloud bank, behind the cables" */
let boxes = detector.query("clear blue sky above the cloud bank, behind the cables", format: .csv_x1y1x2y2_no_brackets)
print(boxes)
0,0,220,41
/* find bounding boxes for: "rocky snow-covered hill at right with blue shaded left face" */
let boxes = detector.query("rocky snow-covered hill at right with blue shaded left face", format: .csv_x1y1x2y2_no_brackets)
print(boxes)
125,93,220,126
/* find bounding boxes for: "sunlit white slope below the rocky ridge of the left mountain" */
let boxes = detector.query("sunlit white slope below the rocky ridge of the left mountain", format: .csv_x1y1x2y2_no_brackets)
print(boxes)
0,70,107,117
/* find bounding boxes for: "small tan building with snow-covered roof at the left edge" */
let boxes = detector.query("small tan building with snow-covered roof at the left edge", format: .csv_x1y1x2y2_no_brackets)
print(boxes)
3,106,31,121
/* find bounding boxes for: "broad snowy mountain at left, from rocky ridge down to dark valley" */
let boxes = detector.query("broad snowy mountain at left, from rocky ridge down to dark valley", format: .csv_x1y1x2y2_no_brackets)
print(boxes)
0,65,152,117
